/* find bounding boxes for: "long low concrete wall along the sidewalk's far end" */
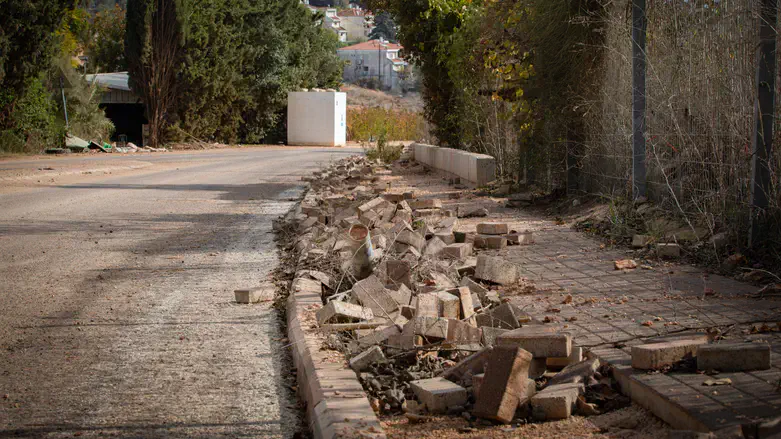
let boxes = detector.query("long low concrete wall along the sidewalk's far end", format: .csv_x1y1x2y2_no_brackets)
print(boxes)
412,143,496,186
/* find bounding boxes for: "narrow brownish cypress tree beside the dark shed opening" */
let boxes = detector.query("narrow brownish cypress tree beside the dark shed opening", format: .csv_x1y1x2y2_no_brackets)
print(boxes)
125,0,188,147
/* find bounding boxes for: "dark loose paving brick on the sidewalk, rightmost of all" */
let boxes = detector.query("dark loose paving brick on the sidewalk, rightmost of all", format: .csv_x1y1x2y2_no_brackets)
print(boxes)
697,343,771,372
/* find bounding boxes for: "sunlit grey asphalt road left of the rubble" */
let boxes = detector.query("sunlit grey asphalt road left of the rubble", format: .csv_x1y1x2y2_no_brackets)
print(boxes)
0,148,357,438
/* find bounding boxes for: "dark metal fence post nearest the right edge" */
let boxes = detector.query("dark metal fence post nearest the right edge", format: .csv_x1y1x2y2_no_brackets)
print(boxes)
748,0,778,247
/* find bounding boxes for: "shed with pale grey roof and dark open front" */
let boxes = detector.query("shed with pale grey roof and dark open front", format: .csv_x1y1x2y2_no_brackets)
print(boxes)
85,72,147,146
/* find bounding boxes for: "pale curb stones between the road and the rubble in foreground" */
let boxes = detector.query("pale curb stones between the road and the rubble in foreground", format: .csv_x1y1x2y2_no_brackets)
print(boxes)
287,201,387,439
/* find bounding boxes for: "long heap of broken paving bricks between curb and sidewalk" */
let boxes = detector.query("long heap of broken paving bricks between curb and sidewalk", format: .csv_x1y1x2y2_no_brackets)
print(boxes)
278,157,626,423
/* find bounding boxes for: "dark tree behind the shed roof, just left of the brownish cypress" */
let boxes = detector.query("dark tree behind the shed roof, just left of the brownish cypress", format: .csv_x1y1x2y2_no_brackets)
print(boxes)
87,5,127,73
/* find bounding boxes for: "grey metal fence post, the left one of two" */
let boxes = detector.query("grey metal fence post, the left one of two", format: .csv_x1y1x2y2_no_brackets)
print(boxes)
632,0,647,199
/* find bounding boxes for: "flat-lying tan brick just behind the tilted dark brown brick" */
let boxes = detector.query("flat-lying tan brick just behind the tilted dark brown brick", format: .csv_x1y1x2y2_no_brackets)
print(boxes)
496,325,572,358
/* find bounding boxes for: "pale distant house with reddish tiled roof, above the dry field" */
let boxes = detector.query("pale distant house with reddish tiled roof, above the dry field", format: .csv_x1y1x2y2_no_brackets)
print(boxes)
337,40,411,92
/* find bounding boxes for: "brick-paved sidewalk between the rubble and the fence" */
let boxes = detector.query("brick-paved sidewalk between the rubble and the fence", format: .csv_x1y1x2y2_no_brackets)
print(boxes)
392,165,781,431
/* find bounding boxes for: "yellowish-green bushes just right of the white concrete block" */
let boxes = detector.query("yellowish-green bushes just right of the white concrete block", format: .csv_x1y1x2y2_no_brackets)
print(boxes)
347,107,426,142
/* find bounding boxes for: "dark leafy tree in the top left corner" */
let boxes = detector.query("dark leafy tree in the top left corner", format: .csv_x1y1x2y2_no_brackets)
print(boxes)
0,0,73,130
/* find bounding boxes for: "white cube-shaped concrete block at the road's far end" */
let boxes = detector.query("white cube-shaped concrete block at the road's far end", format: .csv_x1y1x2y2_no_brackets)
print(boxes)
287,92,347,146
